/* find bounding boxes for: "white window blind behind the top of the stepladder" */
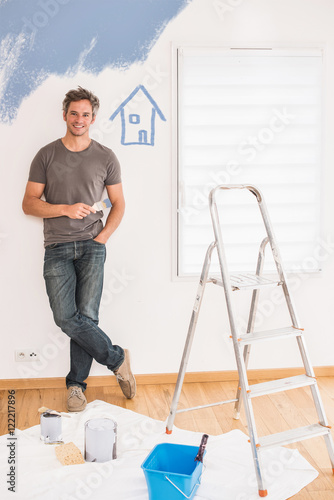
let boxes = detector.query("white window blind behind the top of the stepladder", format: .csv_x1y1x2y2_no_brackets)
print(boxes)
178,47,322,276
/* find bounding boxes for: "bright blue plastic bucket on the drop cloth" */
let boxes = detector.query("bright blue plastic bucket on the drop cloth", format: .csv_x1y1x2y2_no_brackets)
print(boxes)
141,443,203,500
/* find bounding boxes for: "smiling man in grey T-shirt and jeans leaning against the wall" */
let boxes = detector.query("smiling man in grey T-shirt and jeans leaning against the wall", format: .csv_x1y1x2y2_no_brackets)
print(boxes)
22,87,136,411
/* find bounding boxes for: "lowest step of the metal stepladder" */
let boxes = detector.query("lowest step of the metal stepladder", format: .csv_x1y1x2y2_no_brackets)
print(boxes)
259,424,331,449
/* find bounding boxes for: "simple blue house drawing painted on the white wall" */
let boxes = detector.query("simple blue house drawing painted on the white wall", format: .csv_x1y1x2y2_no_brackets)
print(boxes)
109,85,166,146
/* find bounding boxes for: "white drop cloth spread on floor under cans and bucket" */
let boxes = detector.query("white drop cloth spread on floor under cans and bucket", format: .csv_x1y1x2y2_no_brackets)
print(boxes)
0,401,318,500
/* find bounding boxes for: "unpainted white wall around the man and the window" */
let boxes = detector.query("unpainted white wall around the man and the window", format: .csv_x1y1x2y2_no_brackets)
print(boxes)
0,0,334,379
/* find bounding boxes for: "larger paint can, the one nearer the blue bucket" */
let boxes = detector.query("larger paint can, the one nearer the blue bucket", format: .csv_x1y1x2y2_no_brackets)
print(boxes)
85,418,117,462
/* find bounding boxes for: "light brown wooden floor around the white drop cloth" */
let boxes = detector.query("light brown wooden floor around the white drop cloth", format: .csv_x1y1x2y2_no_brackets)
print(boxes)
0,377,334,500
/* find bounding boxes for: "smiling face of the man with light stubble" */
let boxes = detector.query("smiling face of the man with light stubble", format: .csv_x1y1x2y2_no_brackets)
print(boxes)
63,99,95,137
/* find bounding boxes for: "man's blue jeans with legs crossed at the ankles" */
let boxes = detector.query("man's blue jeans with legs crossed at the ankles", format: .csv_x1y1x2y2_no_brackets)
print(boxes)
44,240,124,390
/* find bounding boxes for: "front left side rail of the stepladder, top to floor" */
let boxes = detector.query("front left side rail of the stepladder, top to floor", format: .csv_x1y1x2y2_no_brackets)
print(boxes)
209,186,265,491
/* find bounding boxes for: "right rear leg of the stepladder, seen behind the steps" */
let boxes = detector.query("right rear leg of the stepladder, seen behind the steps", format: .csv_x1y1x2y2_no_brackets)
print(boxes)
233,236,269,420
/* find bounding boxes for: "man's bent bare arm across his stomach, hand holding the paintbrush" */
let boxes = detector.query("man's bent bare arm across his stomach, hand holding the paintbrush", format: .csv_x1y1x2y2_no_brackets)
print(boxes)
22,181,95,219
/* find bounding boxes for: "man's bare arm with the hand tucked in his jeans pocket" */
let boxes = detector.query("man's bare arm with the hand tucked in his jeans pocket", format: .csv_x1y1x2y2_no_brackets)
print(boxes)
94,183,125,243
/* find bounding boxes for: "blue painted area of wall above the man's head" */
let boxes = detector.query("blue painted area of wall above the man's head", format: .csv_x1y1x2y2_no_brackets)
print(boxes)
0,0,188,122
